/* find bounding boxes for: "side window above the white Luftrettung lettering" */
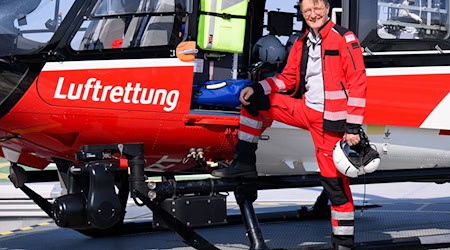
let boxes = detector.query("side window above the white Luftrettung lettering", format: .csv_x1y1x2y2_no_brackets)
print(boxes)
71,0,190,50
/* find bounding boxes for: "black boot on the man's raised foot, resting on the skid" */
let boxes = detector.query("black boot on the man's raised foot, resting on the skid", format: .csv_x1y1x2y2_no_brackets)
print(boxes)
211,140,258,178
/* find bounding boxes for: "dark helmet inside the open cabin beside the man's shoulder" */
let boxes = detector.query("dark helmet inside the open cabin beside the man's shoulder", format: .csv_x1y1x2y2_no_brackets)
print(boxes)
253,35,286,64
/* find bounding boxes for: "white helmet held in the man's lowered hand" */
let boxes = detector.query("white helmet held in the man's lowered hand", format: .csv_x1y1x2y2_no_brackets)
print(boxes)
333,133,380,178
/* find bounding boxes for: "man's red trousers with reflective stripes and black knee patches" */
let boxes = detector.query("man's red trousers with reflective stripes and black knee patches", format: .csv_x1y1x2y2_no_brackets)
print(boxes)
239,93,354,245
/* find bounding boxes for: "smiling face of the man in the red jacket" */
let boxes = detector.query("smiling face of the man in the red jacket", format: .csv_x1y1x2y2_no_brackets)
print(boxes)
301,0,330,32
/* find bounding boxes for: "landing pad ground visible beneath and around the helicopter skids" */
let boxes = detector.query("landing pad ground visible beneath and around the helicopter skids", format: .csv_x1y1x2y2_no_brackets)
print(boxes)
0,183,450,250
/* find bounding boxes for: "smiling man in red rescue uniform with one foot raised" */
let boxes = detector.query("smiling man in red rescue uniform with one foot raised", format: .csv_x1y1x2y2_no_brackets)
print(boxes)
212,0,366,249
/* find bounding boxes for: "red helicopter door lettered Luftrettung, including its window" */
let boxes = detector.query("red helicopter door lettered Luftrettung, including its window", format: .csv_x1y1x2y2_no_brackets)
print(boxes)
38,0,194,113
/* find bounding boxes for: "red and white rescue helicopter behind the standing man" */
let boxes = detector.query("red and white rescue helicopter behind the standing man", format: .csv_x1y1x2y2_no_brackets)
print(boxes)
0,0,450,248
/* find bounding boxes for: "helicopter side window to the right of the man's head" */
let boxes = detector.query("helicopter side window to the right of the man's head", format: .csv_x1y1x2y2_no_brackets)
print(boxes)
358,0,450,52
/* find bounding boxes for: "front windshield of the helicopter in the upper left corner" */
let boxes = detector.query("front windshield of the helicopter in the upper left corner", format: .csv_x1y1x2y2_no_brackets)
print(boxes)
0,0,75,57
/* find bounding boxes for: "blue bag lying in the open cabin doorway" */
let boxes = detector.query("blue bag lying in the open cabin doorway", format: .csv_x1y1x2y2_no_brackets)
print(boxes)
193,79,252,108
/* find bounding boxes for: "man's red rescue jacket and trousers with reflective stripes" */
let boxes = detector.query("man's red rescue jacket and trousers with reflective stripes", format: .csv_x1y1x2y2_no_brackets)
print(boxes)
238,21,366,245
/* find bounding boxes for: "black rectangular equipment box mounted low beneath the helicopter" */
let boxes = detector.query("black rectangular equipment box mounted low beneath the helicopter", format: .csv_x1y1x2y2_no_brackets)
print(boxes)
153,194,227,229
